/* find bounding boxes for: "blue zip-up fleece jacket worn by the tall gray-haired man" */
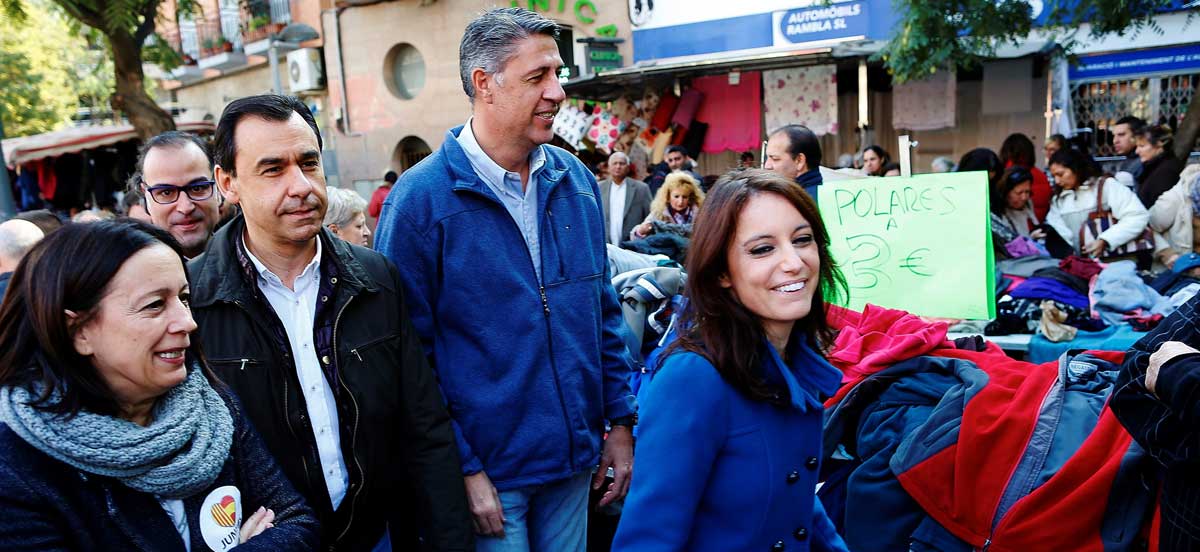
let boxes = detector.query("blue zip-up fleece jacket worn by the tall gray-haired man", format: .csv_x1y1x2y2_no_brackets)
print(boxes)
376,127,635,491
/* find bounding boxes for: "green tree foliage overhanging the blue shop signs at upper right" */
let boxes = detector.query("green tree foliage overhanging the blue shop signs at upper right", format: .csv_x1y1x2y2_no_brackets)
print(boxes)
876,0,1171,83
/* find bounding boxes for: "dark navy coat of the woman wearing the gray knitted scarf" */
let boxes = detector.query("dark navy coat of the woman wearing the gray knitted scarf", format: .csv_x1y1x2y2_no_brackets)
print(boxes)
0,390,318,552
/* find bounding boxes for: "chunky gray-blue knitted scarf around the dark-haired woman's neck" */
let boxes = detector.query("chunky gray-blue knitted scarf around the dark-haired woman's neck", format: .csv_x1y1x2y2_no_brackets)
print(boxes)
0,366,233,498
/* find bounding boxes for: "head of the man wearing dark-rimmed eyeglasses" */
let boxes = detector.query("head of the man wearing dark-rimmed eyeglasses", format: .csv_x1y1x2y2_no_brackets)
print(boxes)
136,131,221,258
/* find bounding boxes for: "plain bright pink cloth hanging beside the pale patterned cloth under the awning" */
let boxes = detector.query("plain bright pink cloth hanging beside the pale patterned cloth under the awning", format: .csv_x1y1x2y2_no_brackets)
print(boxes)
691,72,762,154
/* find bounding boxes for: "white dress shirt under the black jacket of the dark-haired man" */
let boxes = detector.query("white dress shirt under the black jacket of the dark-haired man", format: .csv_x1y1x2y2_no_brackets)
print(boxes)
242,238,349,510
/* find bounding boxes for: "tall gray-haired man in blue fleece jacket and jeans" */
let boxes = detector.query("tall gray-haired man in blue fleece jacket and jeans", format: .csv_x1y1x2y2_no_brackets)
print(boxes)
376,8,636,552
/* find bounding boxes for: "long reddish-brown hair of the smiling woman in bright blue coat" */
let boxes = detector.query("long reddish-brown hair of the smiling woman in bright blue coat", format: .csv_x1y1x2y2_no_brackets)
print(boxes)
662,169,846,403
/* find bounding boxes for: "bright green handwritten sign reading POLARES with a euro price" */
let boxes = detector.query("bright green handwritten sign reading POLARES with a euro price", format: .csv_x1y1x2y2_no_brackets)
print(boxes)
818,173,996,319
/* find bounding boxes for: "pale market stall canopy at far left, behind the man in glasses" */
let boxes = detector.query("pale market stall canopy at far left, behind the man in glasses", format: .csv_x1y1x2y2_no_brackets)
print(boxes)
2,121,216,167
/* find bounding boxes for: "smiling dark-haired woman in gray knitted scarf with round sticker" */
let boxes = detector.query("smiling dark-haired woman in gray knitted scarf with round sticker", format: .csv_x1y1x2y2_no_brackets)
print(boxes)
0,220,318,551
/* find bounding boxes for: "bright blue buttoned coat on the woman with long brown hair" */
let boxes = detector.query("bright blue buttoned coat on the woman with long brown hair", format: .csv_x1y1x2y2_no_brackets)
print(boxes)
612,337,846,552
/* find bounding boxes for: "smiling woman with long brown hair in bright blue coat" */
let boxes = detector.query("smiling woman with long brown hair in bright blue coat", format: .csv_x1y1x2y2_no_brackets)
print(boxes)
613,169,846,552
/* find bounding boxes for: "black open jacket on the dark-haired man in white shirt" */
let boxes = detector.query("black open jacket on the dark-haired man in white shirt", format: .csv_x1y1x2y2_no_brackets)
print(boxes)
188,217,474,551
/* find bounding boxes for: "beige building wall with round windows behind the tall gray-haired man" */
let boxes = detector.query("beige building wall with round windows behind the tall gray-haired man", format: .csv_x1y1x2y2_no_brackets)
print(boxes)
322,0,632,194
